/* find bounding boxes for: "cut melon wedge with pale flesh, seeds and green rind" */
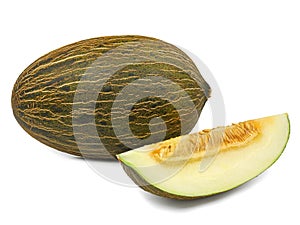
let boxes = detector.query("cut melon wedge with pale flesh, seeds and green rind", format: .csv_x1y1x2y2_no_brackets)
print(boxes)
117,114,290,199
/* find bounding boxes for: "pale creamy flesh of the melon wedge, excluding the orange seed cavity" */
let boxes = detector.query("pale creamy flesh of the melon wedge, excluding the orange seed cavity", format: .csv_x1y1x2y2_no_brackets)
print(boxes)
118,114,290,197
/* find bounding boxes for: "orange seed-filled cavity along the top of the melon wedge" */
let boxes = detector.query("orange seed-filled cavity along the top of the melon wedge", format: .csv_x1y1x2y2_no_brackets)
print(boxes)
150,120,261,163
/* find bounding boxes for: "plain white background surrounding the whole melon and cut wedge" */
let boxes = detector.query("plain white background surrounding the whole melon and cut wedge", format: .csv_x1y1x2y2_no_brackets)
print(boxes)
0,0,300,225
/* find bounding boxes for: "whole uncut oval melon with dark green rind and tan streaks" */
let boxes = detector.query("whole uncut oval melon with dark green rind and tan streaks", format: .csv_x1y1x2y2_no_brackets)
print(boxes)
11,35,210,159
